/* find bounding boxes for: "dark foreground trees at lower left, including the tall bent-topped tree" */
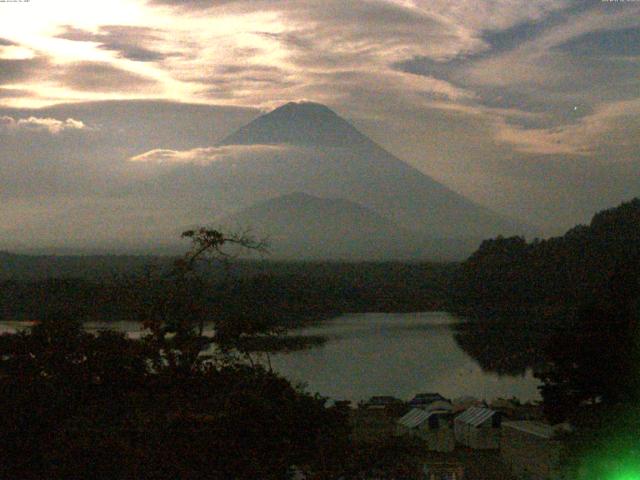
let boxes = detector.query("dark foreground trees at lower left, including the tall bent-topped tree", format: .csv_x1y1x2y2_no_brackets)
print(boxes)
0,229,349,480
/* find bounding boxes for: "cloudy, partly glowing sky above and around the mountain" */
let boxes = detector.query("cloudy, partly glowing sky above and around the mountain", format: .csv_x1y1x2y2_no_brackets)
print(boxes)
0,0,640,248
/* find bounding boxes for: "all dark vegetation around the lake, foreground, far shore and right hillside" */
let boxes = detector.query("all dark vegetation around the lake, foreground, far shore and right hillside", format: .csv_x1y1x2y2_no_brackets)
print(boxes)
0,200,640,480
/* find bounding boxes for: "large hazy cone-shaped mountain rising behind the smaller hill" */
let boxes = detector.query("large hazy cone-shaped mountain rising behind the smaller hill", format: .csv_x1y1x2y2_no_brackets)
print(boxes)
149,102,534,256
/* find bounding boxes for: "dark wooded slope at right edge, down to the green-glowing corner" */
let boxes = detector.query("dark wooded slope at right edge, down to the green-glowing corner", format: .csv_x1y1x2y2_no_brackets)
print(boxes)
454,199,640,480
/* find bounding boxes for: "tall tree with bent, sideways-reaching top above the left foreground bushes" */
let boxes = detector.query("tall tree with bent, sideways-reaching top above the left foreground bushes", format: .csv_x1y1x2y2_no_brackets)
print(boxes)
116,227,282,369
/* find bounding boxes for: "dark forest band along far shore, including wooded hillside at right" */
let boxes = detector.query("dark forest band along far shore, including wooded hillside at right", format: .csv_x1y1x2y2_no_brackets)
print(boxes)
0,199,640,333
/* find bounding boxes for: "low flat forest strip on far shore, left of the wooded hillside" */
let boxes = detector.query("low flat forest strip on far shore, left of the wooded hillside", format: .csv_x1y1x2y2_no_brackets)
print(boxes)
0,259,455,326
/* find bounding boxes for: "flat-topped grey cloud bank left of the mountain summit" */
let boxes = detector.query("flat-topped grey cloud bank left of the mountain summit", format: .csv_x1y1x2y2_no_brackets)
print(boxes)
0,101,257,202
